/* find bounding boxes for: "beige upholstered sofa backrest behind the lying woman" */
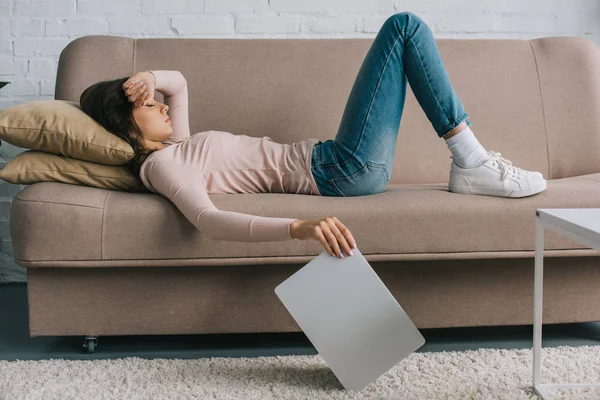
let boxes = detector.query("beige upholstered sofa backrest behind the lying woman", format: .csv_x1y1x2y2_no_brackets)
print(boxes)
55,35,600,183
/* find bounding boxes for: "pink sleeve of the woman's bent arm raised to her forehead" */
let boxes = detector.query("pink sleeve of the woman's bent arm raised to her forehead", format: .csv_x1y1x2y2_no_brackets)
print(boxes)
147,70,190,145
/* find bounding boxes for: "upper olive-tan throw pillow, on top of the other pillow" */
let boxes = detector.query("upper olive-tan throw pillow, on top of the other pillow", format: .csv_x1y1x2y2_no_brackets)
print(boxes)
0,100,134,165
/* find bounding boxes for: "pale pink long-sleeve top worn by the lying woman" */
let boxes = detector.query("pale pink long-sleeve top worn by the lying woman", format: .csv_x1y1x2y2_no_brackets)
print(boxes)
140,70,320,242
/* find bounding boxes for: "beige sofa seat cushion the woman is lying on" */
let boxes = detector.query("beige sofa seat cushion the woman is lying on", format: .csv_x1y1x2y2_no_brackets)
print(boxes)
10,173,600,267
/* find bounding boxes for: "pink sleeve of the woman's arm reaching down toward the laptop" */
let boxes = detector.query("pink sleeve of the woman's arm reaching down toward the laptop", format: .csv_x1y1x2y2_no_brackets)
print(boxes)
142,160,296,242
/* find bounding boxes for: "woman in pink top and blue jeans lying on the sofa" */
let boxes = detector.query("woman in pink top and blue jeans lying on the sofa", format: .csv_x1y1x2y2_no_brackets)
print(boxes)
80,12,546,258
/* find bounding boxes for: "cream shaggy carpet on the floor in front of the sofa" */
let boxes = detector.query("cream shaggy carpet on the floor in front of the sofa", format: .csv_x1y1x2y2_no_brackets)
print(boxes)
0,346,600,400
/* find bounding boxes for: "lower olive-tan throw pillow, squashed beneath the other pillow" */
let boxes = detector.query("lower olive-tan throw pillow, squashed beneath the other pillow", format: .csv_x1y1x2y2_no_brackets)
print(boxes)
0,150,151,193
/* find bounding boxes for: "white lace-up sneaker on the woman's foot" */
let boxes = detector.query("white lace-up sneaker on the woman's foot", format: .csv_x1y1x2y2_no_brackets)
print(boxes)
448,151,546,197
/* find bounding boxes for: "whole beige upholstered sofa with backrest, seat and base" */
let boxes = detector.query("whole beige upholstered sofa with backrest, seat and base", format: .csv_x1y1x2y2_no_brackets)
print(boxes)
10,36,600,351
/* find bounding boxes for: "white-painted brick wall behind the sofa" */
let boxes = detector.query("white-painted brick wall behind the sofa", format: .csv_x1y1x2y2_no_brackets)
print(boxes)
0,0,600,282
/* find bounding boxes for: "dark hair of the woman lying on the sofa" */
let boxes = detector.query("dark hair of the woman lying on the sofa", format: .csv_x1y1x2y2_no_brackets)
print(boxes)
79,78,156,179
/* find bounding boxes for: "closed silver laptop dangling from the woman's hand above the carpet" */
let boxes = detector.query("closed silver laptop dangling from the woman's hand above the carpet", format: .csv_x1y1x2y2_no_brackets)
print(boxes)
275,249,425,391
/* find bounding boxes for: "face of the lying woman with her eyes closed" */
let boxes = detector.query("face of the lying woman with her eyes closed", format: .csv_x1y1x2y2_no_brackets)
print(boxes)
132,100,173,147
